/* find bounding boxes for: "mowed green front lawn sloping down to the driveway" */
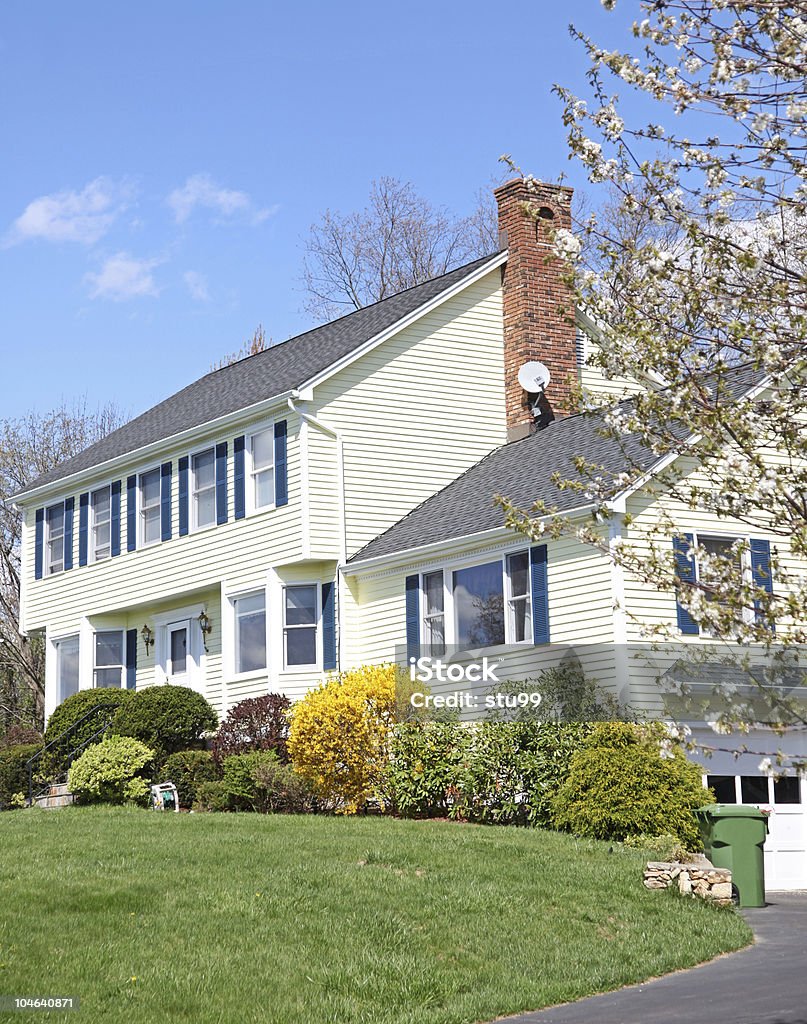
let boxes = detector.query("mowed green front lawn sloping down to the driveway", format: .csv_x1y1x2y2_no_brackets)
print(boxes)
0,808,751,1024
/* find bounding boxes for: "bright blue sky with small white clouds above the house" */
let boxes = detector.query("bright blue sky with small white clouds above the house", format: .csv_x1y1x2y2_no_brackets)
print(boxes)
0,0,637,419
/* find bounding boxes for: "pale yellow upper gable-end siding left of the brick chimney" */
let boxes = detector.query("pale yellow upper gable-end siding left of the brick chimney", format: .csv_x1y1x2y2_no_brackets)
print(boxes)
309,270,506,557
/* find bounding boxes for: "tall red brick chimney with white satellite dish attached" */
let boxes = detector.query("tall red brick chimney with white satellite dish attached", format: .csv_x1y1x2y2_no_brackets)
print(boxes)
494,178,578,440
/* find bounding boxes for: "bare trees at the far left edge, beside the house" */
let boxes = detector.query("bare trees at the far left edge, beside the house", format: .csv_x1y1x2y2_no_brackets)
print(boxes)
0,399,124,726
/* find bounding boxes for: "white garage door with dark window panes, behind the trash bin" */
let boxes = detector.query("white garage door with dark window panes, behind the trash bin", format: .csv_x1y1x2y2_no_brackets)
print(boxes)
704,775,807,891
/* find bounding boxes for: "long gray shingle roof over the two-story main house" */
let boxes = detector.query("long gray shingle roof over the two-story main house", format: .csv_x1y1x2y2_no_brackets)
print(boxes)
20,253,498,494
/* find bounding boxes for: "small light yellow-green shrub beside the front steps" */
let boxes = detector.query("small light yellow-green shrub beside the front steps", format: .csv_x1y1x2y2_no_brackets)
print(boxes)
68,736,154,804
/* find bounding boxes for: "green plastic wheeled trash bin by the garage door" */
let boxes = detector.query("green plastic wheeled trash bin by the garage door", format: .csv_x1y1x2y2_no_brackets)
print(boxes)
695,804,768,906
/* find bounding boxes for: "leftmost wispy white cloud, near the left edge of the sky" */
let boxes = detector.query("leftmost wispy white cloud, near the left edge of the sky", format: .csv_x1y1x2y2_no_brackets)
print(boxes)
4,178,132,246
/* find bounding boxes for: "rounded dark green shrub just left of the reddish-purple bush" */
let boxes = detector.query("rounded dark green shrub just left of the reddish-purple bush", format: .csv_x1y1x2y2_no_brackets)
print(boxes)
113,686,218,763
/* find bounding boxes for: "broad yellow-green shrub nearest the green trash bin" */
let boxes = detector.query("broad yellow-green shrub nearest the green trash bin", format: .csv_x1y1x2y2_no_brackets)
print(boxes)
552,723,711,850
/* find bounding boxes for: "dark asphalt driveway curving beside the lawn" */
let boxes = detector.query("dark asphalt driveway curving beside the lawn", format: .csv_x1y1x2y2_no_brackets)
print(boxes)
504,893,807,1024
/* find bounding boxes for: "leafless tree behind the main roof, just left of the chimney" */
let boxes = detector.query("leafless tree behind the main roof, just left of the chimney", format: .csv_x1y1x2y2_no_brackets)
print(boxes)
303,177,498,322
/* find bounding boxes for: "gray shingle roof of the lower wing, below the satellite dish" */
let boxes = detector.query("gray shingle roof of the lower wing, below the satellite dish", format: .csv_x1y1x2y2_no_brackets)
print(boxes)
348,367,764,564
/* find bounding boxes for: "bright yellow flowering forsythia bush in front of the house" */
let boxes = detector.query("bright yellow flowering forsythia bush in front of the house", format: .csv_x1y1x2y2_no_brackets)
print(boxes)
288,665,395,813
